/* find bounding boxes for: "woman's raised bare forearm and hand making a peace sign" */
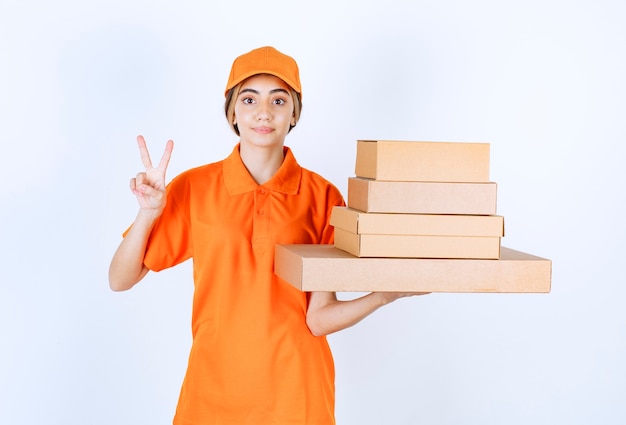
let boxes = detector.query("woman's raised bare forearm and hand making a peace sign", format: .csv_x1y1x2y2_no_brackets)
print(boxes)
109,136,174,291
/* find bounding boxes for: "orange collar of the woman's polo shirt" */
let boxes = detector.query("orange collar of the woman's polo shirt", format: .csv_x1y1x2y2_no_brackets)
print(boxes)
223,144,302,195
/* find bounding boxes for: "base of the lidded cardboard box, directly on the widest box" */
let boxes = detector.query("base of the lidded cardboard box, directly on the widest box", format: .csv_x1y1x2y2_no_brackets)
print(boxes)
335,227,500,260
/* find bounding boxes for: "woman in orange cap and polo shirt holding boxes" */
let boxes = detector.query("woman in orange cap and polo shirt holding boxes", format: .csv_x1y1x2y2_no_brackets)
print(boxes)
109,47,424,425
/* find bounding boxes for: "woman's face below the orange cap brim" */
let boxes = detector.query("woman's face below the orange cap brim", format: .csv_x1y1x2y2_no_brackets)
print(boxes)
234,74,296,147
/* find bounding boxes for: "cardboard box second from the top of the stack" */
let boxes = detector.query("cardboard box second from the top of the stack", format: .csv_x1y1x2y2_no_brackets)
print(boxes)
348,177,497,215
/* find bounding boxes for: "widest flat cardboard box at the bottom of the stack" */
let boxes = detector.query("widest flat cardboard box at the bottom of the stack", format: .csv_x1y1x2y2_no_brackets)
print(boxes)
274,244,552,293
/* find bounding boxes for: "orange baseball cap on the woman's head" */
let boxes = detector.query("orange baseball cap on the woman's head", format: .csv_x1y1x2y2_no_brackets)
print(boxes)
224,46,302,96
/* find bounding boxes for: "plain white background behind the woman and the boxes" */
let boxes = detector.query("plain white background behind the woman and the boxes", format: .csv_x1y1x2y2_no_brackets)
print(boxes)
0,0,626,425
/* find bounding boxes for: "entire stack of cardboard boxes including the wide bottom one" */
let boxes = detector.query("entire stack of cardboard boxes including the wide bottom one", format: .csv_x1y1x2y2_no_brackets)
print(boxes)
274,140,552,293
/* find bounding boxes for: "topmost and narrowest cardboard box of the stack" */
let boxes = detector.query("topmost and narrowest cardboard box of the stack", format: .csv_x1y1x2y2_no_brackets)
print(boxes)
355,140,489,183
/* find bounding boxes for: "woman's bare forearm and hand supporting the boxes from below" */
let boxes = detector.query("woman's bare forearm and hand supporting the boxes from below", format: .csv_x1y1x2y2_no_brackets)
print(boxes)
306,292,427,336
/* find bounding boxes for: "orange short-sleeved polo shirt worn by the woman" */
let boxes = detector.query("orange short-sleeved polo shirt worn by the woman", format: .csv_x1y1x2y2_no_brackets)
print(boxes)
144,146,345,425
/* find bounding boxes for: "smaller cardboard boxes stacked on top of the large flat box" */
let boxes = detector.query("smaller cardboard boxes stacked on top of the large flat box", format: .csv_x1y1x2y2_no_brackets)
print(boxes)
330,140,504,259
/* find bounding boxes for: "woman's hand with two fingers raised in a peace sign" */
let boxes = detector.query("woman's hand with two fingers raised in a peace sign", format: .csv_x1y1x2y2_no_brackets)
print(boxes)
130,135,174,217
